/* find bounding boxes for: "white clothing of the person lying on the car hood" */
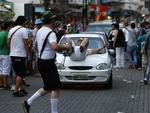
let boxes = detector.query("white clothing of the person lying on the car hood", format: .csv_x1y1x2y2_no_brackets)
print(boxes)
70,46,92,61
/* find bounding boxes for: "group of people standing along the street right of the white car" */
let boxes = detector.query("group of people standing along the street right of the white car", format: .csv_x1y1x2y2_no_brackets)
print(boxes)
109,18,150,84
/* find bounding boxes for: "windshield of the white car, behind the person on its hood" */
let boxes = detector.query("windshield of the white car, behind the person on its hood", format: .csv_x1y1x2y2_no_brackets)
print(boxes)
59,37,106,54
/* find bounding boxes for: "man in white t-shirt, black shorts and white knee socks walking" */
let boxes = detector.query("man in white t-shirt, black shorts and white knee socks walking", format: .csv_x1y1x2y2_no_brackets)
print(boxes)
22,11,69,113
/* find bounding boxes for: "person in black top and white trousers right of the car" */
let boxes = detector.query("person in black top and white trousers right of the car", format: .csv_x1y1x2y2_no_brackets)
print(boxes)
112,23,125,68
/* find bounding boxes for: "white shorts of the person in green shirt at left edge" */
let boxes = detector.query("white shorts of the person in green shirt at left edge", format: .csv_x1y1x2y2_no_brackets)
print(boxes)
0,55,11,76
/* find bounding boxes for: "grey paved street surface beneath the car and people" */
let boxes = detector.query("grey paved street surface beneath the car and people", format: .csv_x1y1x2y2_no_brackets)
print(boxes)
0,68,150,113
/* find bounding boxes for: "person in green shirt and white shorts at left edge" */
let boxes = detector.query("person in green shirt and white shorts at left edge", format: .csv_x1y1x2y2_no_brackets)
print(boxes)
0,22,11,89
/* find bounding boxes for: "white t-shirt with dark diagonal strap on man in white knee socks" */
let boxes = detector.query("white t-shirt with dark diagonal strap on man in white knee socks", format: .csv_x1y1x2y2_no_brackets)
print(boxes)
36,26,57,60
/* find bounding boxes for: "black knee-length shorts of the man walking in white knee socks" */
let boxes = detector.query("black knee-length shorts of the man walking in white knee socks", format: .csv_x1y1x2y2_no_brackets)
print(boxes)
37,59,61,91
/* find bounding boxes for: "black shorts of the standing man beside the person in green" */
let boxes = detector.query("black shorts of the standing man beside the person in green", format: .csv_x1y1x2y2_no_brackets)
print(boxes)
11,56,26,77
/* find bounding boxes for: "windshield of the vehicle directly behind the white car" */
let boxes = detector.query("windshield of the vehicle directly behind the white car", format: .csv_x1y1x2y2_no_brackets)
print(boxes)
86,24,112,34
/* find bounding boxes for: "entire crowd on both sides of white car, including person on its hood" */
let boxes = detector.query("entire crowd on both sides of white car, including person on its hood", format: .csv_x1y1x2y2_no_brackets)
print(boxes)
0,11,150,113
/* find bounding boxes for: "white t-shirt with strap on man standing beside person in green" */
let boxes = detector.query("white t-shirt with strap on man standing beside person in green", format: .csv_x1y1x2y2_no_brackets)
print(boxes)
8,25,28,57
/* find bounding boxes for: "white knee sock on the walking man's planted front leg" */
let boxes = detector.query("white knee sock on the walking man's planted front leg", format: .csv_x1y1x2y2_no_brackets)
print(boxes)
50,98,58,113
